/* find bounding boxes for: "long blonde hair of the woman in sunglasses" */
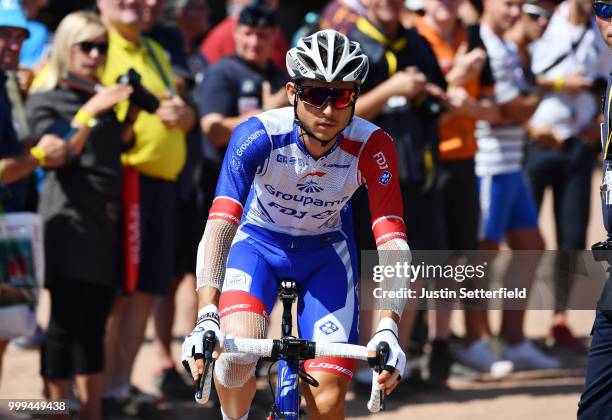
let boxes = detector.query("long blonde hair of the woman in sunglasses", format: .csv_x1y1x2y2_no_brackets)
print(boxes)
32,11,107,92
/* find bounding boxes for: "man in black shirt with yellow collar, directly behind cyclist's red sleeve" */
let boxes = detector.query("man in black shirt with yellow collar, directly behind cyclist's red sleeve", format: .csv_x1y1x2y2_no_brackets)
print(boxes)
348,0,446,380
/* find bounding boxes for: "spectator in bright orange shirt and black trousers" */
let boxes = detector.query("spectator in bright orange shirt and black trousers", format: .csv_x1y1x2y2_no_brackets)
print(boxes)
416,0,498,386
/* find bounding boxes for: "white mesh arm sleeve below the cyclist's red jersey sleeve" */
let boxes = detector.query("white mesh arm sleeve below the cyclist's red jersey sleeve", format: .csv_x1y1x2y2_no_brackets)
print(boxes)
377,238,412,318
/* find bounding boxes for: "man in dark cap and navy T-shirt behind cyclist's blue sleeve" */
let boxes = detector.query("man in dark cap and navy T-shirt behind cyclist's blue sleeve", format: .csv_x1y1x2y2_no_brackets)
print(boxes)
196,4,288,150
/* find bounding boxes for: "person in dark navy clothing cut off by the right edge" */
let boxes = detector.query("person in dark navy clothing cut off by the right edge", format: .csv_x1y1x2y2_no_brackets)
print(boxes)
578,0,612,420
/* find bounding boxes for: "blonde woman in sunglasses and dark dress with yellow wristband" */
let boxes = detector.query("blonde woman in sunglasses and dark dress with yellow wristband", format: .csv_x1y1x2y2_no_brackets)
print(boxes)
27,12,137,420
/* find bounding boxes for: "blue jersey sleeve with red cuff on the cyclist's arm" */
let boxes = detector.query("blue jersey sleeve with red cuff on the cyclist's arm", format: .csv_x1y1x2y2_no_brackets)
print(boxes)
208,117,272,225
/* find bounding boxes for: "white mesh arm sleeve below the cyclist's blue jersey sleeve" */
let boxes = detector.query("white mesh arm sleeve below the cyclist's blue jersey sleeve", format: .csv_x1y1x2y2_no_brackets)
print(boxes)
196,219,238,290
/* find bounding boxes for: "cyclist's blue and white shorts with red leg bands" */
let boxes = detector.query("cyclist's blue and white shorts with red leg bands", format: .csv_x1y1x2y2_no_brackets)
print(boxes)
219,224,359,379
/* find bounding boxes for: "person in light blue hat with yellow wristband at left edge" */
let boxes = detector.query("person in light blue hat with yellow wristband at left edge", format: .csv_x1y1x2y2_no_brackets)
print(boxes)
0,0,66,380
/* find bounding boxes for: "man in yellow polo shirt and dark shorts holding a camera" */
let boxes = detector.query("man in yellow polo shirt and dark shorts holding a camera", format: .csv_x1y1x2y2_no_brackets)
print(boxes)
97,0,195,410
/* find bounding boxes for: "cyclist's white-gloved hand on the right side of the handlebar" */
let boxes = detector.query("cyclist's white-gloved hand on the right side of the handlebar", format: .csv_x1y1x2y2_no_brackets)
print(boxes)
367,318,406,395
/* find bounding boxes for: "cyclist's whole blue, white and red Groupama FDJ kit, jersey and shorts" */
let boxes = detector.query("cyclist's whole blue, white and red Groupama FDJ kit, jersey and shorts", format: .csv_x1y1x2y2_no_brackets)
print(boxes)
209,108,406,378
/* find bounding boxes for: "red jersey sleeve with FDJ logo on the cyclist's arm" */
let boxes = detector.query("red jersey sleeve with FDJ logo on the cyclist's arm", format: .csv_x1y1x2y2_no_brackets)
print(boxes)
359,129,406,246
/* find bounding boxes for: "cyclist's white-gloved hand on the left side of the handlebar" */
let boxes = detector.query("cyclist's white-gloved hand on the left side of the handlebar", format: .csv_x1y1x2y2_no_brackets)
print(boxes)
182,305,223,381
